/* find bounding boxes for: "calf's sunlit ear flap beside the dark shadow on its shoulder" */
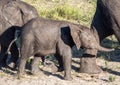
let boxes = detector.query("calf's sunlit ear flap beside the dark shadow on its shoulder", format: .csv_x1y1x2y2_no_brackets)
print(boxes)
70,25,81,50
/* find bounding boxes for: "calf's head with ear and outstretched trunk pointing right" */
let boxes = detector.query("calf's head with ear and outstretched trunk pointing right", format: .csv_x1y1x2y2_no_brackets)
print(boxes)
70,25,114,51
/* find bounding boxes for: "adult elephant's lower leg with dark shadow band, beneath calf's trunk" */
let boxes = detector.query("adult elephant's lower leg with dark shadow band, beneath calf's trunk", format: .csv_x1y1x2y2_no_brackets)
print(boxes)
80,49,102,74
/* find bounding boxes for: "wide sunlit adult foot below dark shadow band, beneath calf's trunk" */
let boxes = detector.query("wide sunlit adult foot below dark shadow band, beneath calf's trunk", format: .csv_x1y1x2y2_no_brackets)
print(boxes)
79,57,103,74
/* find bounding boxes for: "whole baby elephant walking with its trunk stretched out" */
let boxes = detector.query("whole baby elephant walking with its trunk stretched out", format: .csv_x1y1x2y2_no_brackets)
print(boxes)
18,18,112,80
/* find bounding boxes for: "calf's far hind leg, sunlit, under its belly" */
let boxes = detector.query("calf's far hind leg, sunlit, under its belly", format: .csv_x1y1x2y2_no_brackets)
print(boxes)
31,57,41,75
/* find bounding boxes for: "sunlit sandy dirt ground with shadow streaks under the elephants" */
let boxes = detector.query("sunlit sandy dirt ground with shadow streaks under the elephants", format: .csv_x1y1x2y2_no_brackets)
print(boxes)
0,55,120,85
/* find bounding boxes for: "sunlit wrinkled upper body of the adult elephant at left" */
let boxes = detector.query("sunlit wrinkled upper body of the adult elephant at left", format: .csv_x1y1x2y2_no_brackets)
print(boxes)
0,0,38,35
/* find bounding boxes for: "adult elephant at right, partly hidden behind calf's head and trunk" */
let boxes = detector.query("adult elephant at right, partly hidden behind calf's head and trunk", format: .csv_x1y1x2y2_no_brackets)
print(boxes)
81,0,120,73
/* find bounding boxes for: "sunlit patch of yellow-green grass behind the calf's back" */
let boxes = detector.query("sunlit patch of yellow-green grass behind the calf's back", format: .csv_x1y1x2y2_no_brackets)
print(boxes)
24,0,96,26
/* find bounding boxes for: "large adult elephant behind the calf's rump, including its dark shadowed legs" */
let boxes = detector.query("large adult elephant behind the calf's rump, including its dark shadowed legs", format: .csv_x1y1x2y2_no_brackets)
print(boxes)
0,0,38,68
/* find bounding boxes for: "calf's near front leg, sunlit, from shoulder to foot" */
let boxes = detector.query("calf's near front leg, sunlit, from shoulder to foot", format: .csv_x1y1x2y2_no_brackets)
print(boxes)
56,39,72,80
